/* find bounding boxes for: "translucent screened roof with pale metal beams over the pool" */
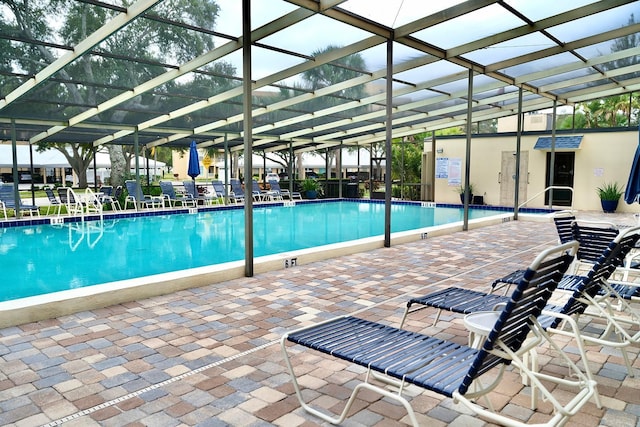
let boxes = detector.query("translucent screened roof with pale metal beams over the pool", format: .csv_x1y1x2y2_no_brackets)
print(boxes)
0,0,640,146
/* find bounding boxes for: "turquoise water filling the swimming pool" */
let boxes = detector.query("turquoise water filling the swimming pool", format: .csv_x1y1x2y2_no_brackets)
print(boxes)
0,201,504,301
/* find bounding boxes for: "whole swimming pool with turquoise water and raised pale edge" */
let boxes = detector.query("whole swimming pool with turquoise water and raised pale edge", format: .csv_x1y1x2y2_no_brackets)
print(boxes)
0,200,552,327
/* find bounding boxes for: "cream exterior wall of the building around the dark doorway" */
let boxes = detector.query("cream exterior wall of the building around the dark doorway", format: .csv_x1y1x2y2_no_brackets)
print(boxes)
432,130,640,213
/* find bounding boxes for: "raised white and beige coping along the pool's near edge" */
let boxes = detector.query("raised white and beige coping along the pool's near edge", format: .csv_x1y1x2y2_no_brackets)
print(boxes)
0,212,550,328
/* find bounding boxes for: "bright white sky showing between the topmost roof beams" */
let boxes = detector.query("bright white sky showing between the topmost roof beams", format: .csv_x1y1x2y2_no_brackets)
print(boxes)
209,0,620,92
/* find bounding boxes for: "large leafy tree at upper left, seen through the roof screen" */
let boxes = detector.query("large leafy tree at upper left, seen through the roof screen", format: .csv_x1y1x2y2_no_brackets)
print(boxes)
0,0,234,186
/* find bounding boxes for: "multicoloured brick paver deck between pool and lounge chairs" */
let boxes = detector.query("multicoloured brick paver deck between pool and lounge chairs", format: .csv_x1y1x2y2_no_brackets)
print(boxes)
0,214,640,427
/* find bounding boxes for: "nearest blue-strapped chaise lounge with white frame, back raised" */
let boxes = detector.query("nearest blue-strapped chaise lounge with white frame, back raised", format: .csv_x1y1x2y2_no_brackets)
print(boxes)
280,242,596,426
